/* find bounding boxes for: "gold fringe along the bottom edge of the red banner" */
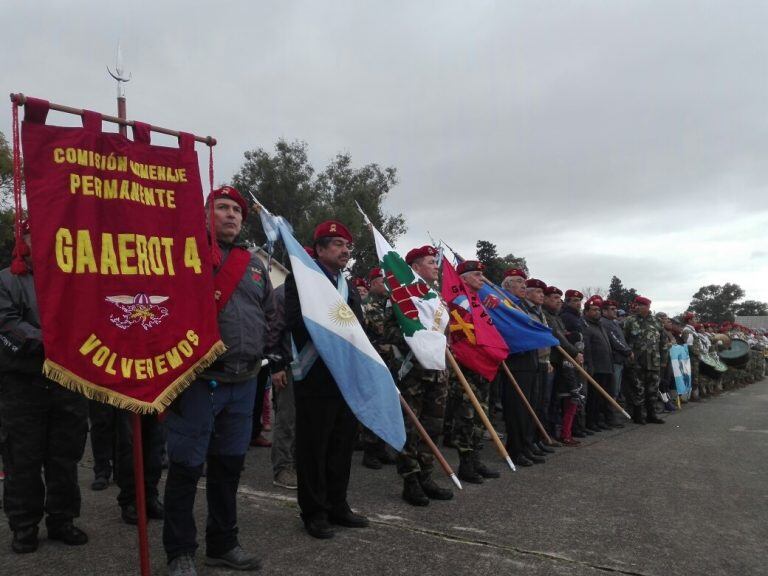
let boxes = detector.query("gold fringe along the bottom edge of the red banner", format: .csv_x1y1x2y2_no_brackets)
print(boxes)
43,340,227,414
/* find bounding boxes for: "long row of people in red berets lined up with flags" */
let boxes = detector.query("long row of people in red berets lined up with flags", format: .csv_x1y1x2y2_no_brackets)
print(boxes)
0,187,768,576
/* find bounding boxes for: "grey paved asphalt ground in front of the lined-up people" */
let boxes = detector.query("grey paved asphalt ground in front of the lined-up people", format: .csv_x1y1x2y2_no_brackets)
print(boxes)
0,380,768,576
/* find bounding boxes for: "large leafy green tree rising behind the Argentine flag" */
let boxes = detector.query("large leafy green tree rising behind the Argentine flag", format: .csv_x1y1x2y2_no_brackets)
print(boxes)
232,140,406,276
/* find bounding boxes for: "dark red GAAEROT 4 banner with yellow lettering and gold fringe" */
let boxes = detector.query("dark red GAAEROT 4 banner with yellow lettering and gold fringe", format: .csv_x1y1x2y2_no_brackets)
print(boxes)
22,101,224,413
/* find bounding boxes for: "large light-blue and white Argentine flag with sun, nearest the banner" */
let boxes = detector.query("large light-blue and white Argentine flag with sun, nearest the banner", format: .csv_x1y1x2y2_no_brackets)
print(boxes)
276,215,405,452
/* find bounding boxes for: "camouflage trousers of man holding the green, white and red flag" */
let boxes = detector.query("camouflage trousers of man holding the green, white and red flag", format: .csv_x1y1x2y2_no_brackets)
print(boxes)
397,366,448,477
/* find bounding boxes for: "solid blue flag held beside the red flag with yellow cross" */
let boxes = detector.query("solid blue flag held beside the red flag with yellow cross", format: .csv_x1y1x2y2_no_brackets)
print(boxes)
478,284,560,354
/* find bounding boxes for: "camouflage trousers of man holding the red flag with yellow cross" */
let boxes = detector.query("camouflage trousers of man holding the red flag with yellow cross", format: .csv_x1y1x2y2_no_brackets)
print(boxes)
449,369,491,454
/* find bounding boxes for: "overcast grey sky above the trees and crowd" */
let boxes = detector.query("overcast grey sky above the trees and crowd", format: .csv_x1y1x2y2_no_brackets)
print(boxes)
0,0,768,312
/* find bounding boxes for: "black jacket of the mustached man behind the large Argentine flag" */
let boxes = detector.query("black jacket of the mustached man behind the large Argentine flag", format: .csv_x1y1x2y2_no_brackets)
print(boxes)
285,266,365,397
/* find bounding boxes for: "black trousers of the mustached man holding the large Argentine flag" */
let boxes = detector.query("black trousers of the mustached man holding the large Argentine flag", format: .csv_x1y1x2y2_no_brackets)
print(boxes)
294,386,357,520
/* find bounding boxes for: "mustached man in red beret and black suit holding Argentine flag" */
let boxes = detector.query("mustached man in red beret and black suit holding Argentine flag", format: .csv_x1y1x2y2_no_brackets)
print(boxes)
285,220,368,538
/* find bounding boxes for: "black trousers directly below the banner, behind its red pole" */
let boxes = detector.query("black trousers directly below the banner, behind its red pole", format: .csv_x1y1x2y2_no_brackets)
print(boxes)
115,410,165,506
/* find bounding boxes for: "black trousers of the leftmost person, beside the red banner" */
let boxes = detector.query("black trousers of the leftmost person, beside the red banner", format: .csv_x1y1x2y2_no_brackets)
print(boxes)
0,373,88,531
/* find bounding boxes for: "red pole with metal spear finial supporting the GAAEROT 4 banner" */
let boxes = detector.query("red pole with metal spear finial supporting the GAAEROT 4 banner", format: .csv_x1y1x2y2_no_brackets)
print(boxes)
107,42,150,576
